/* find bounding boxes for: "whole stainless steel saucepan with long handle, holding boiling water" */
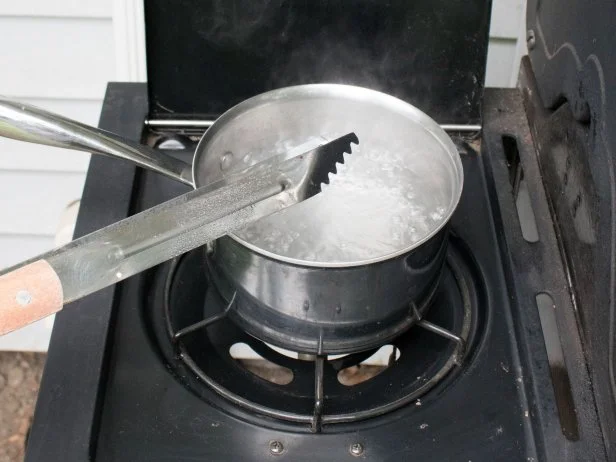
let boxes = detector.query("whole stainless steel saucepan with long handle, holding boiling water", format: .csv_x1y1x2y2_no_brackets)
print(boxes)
0,84,463,354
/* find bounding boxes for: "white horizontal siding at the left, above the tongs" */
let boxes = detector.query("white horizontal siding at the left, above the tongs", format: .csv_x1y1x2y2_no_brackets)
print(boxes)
0,7,115,258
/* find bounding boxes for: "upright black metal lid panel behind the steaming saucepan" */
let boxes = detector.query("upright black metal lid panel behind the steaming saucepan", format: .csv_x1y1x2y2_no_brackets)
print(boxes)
145,0,491,124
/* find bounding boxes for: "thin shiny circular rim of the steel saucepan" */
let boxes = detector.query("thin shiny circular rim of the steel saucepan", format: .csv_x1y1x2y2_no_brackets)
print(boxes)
192,83,464,268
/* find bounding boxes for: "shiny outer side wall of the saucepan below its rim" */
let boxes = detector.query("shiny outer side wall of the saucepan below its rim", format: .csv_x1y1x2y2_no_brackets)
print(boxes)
206,230,450,355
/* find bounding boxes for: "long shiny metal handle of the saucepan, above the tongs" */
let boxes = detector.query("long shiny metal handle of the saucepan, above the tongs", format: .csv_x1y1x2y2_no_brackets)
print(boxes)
0,96,194,186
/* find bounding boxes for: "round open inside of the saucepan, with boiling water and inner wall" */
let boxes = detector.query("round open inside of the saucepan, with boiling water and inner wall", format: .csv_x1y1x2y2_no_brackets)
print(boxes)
199,85,462,266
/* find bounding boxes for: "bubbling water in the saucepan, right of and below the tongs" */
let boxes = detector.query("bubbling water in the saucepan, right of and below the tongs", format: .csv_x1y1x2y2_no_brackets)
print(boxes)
236,132,452,263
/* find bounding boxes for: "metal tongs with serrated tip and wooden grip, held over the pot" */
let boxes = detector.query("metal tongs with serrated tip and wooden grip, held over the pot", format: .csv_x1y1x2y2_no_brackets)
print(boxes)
0,133,359,335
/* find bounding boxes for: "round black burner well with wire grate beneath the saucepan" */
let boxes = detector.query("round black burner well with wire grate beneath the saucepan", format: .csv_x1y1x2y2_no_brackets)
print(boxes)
151,236,482,432
